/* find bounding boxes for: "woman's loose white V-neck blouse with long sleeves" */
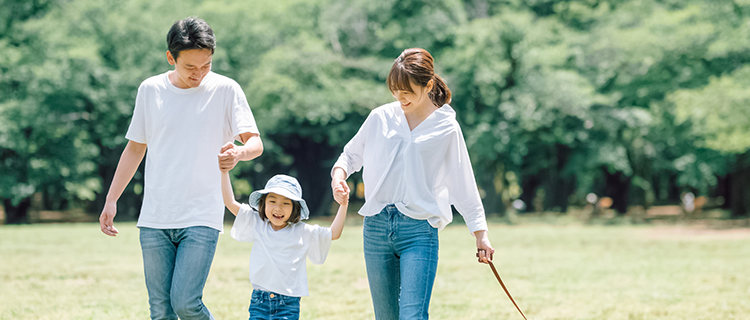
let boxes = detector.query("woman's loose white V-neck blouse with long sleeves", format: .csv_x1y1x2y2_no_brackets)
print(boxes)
331,101,487,232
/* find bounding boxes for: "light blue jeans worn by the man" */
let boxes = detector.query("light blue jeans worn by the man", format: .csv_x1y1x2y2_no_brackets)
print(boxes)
140,227,219,320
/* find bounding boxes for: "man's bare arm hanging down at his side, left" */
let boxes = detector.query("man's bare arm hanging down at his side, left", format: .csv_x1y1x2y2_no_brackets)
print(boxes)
99,141,146,237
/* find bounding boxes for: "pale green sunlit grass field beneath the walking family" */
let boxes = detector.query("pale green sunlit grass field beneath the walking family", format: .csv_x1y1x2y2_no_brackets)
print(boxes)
0,218,750,320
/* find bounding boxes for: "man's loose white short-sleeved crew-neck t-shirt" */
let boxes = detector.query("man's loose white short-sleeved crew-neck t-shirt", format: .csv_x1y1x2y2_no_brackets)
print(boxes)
125,72,258,231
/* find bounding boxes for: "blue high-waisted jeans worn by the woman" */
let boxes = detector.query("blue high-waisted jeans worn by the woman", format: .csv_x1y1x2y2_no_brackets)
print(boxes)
363,205,439,320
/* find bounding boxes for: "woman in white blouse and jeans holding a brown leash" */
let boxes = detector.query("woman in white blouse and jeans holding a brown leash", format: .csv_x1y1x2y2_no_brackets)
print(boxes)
331,48,495,319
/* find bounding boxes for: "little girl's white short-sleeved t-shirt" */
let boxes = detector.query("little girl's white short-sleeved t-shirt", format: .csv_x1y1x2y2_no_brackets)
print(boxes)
231,204,331,297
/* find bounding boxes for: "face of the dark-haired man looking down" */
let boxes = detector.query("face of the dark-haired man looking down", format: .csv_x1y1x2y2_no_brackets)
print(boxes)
167,49,212,89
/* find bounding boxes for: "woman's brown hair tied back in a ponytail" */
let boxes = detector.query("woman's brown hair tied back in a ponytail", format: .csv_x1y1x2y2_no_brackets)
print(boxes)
385,48,451,108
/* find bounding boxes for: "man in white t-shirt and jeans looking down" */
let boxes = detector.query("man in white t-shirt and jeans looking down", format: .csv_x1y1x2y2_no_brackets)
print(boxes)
99,18,263,320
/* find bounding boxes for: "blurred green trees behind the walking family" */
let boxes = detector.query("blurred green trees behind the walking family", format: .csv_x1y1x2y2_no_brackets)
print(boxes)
0,0,750,224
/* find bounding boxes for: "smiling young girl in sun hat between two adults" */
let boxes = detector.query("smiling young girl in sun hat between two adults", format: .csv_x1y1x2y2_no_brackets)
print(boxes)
221,171,349,320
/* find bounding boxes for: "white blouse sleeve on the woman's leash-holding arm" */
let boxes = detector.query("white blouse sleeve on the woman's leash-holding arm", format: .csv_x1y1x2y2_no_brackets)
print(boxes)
445,124,487,233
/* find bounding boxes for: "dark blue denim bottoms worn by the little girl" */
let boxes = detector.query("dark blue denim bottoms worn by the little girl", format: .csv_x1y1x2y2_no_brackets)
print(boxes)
247,290,300,320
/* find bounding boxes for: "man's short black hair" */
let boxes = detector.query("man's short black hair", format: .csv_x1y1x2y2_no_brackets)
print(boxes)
167,17,216,60
